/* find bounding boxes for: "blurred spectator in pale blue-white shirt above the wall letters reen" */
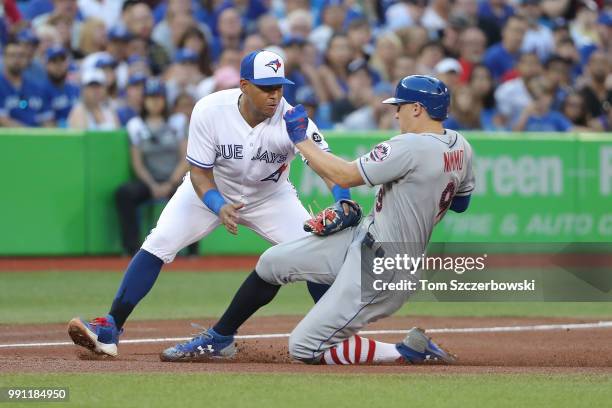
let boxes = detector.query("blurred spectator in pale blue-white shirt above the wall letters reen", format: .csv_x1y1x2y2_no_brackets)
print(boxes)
494,54,542,128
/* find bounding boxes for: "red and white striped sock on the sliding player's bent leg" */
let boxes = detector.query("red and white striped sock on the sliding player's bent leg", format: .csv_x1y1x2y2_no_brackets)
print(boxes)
321,336,401,365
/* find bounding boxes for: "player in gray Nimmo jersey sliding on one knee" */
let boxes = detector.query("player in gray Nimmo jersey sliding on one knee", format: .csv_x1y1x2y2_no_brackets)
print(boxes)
161,75,474,364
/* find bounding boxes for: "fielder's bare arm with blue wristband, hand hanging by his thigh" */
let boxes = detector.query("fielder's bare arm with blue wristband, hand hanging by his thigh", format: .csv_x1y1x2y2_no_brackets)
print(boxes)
189,166,244,235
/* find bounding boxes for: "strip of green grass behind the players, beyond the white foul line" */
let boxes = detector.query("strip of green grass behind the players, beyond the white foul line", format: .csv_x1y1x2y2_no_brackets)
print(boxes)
0,272,612,323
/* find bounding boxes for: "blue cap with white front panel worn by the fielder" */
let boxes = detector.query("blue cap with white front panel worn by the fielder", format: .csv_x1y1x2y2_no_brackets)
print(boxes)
240,50,294,86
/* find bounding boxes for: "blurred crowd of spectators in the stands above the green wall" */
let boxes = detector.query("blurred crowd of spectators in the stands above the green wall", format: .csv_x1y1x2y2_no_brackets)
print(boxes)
0,0,612,132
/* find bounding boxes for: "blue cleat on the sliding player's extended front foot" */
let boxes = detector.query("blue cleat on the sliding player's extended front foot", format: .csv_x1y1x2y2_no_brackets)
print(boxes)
159,328,236,362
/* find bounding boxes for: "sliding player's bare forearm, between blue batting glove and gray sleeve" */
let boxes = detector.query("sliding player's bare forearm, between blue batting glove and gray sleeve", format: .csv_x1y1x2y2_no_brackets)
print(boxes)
295,139,365,188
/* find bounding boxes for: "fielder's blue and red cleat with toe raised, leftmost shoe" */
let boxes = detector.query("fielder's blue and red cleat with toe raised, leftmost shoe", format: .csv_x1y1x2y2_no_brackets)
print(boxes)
68,315,123,357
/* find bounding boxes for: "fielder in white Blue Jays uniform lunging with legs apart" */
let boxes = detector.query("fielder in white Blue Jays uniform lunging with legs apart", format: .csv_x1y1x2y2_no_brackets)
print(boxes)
68,50,350,356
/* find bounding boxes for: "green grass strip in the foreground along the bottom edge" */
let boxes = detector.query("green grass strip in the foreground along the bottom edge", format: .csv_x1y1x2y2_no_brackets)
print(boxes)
0,367,612,408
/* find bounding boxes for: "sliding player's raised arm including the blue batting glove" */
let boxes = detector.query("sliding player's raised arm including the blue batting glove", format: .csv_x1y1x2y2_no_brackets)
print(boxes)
284,105,365,188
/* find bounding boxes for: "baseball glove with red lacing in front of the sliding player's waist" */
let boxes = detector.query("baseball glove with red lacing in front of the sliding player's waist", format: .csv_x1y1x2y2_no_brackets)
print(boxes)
304,199,362,237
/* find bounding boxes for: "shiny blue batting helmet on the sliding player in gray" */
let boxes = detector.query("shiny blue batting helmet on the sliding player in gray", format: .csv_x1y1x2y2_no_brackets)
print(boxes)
383,75,450,120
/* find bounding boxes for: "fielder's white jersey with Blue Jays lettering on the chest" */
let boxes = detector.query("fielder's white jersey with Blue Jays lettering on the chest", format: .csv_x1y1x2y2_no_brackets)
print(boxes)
187,89,328,204
